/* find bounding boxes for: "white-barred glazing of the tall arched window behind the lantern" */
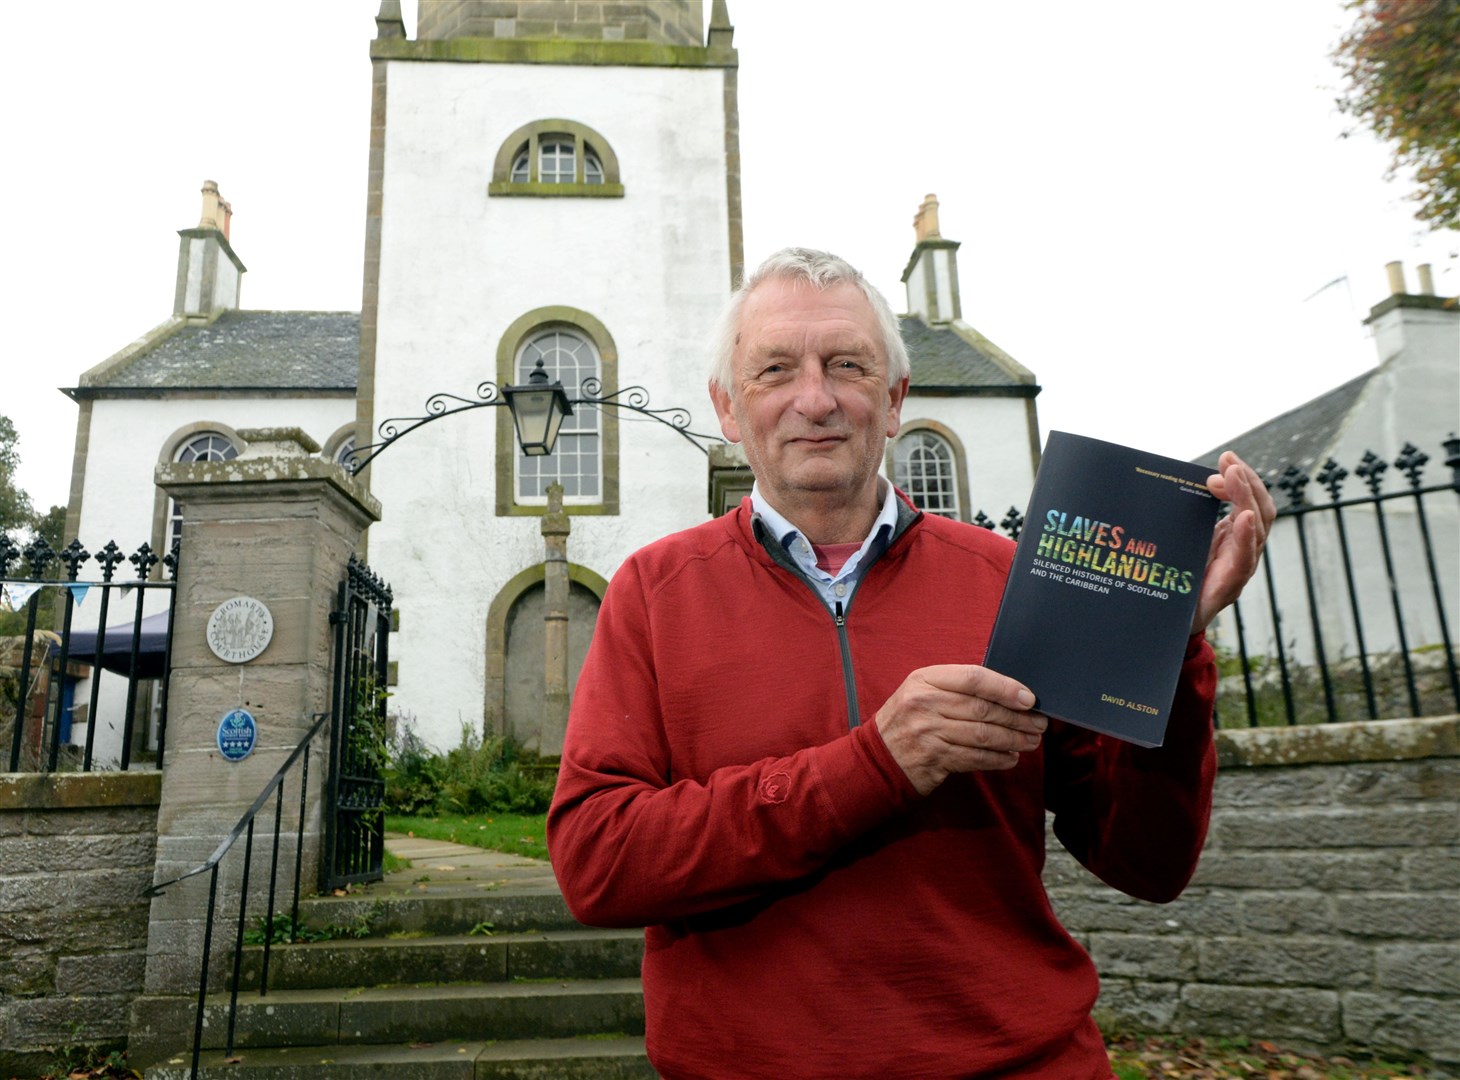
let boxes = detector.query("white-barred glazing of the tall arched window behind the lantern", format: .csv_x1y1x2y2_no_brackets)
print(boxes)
515,325,603,505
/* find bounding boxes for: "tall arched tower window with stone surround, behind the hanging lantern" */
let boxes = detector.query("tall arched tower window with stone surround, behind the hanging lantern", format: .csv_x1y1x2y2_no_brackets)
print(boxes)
496,305,619,515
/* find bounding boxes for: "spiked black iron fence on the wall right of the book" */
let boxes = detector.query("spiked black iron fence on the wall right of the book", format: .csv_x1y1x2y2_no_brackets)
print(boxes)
1212,436,1460,727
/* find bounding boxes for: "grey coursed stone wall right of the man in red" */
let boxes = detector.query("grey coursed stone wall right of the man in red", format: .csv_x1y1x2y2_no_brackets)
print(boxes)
1045,717,1460,1062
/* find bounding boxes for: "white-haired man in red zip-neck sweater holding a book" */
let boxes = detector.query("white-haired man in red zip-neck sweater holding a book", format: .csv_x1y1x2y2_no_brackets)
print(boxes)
548,248,1273,1080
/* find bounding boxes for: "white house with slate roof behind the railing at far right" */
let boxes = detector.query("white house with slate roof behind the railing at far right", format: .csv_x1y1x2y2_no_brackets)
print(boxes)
1200,263,1460,663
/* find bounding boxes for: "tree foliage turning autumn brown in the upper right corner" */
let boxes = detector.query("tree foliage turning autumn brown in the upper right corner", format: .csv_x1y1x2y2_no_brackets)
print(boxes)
1333,0,1460,229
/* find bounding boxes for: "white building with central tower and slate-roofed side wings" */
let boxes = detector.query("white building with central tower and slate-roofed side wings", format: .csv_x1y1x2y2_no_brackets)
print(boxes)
56,0,1040,753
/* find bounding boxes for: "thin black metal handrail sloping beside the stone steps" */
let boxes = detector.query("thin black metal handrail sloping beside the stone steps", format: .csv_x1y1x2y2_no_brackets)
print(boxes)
142,712,330,1080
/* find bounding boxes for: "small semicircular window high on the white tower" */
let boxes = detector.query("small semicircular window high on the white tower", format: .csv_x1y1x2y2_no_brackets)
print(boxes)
488,120,623,197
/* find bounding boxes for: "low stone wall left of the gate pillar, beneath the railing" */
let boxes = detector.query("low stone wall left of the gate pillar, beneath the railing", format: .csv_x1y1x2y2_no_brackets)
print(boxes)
0,772,162,1077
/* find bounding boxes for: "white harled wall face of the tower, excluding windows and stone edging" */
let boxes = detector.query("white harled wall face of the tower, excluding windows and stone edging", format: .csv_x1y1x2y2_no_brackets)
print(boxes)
369,61,730,747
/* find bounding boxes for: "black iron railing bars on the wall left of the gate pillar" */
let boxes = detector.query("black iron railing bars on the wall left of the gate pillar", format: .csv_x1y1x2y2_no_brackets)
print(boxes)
0,533,178,772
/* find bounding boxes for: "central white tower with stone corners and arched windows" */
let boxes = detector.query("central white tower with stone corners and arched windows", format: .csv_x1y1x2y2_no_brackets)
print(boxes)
356,0,743,753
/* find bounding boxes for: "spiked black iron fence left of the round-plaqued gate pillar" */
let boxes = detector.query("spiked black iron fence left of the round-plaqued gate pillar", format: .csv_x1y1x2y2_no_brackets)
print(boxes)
0,533,178,772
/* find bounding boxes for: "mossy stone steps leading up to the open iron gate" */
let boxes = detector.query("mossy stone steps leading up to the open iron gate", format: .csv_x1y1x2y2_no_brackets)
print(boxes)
133,852,656,1080
